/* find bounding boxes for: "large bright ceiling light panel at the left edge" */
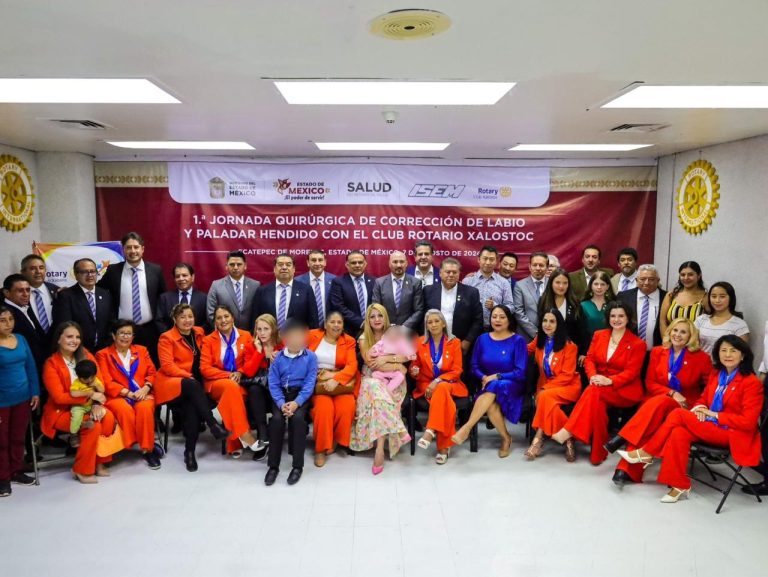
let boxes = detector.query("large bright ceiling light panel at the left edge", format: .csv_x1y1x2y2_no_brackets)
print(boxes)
0,78,179,104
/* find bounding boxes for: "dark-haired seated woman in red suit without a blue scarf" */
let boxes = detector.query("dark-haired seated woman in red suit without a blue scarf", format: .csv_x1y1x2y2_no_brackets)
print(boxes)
552,301,646,465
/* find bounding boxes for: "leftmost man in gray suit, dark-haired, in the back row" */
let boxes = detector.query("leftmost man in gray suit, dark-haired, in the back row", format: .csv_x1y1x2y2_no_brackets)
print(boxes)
206,250,260,332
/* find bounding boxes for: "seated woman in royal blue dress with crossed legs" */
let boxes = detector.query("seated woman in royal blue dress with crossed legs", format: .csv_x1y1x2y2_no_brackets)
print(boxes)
451,305,528,459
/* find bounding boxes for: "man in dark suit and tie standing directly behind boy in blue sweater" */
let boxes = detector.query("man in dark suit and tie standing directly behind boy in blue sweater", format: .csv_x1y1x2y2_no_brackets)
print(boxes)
253,253,317,331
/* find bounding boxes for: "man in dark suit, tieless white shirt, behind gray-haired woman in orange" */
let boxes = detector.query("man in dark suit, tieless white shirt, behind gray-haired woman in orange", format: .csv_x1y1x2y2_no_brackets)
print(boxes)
424,257,483,355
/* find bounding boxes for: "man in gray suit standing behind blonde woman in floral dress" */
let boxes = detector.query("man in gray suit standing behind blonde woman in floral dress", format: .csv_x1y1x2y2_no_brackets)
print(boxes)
373,251,424,333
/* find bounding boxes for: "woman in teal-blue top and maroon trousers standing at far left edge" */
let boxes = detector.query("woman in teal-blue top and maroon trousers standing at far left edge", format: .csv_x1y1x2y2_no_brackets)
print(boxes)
0,305,40,497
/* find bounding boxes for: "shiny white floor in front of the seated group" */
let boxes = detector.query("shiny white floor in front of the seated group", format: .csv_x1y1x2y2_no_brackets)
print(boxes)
0,426,768,577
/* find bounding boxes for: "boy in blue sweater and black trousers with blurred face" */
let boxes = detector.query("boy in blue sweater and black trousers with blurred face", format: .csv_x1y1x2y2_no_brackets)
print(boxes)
264,319,317,486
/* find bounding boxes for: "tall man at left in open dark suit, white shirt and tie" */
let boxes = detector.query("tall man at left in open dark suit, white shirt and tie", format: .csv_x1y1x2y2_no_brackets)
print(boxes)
98,232,166,364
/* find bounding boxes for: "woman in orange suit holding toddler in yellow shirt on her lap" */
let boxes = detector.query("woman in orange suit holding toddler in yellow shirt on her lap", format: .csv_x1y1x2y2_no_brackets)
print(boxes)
40,321,115,484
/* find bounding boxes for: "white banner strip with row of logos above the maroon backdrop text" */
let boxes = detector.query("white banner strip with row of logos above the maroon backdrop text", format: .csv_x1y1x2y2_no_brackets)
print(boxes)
168,162,550,208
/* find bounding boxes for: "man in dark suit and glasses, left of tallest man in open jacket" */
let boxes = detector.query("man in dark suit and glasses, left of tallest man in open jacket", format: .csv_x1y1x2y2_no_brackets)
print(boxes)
53,258,115,352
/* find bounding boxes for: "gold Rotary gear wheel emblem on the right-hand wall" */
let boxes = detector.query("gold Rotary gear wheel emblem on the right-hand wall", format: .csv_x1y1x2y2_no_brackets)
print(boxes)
676,160,720,235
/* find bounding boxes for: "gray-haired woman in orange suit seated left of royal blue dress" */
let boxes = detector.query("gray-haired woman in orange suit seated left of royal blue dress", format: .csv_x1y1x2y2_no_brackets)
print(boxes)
411,309,469,465
